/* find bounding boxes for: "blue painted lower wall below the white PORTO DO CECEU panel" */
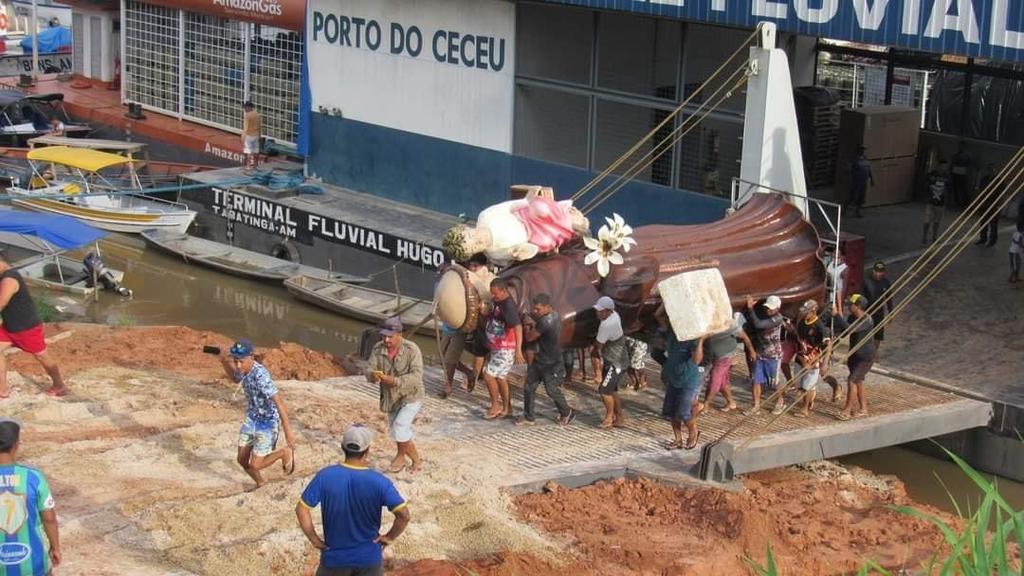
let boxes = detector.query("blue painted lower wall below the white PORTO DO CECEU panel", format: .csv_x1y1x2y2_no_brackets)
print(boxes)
308,113,728,225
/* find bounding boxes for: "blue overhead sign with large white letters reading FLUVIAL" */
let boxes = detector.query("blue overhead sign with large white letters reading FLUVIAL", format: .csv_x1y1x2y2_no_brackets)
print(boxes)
545,0,1024,60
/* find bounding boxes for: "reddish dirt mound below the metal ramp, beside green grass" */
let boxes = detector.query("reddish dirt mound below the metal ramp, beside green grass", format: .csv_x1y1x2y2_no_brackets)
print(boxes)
499,464,954,576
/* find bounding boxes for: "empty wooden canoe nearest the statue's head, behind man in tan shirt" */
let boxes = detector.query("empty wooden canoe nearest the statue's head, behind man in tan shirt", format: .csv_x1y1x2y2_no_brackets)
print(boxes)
285,276,434,335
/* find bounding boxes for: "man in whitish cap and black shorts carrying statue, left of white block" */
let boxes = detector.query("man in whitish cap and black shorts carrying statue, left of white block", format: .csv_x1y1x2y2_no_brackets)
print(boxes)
594,296,630,428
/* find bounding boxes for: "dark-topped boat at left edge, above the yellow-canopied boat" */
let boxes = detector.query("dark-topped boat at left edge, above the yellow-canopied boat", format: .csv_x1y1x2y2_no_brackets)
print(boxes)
0,90,92,146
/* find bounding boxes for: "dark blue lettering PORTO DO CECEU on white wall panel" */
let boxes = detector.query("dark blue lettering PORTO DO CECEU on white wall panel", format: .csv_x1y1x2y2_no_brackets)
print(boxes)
312,10,506,72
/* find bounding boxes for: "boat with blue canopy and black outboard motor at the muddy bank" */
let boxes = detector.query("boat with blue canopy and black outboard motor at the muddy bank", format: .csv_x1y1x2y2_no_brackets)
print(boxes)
0,209,124,296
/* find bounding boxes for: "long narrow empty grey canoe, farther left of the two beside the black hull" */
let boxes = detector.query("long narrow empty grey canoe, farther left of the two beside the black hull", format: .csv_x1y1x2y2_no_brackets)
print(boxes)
141,230,370,284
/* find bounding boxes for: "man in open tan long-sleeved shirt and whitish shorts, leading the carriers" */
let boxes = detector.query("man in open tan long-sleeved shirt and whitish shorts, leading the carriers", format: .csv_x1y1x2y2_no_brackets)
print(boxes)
367,318,424,474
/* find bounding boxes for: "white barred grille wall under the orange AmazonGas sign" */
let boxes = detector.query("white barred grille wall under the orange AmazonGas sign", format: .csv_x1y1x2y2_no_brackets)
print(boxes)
124,0,303,142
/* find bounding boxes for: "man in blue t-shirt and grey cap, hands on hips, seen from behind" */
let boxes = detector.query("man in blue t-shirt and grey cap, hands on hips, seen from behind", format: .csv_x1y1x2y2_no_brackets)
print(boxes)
295,424,410,576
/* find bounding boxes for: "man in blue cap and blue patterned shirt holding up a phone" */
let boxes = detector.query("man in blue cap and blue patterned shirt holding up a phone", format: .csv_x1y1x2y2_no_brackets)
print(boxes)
220,338,295,488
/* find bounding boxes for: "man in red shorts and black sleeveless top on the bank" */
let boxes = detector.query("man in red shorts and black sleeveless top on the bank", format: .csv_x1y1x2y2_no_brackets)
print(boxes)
0,252,68,399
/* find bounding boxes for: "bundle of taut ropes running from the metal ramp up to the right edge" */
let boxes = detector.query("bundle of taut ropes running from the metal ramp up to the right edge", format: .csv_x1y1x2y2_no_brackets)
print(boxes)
712,148,1024,450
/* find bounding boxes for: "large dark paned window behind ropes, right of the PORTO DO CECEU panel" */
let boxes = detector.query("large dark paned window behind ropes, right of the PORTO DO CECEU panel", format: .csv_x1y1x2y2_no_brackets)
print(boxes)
514,2,751,197
